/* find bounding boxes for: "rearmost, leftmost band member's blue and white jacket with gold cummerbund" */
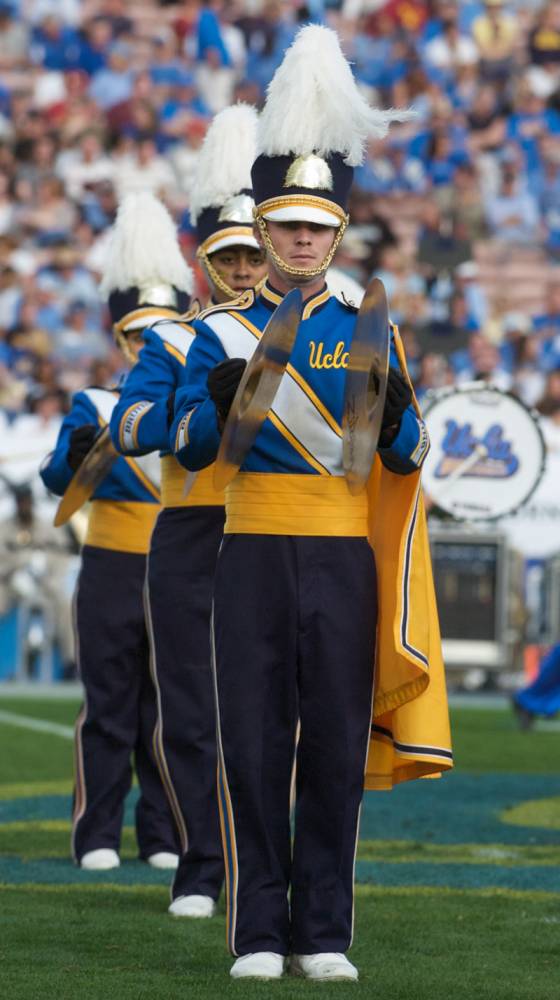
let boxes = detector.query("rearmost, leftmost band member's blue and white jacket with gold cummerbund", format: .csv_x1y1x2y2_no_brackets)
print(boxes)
41,387,160,553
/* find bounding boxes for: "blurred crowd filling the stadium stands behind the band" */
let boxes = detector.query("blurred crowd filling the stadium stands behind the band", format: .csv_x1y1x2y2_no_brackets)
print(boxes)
0,0,560,457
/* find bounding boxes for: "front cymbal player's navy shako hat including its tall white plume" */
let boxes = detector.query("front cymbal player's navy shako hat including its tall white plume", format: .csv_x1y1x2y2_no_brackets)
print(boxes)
252,24,413,232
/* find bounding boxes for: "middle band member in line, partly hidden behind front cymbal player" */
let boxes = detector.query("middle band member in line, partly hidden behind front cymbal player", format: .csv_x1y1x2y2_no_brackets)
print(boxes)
111,105,265,917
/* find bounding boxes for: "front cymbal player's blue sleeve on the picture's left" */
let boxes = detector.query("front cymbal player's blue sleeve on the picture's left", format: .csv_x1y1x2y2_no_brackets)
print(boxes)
169,320,227,472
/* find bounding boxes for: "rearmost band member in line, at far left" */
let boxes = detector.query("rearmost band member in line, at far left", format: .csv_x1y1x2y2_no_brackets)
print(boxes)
41,194,192,870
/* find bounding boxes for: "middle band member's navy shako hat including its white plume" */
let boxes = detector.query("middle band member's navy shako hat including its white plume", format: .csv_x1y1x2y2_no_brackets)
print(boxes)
191,104,259,256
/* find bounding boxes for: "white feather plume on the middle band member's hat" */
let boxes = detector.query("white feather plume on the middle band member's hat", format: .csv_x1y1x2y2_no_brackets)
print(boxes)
191,104,258,225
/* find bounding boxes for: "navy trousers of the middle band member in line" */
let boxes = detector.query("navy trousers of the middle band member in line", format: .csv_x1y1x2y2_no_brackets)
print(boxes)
147,507,224,899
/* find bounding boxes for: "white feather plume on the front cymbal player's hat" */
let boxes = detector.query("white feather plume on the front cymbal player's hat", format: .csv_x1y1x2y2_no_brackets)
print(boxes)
258,24,414,167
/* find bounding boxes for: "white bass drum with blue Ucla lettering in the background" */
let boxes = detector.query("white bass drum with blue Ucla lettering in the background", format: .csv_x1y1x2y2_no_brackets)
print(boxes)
422,382,546,521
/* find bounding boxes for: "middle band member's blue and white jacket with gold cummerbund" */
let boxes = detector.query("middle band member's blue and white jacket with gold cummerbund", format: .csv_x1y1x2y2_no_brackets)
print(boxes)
110,320,224,507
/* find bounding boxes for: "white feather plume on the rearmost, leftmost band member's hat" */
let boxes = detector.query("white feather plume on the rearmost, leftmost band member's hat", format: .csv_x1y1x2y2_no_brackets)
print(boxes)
100,191,194,296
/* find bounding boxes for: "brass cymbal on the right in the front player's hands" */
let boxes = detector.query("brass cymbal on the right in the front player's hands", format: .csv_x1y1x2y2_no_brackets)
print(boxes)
342,278,390,494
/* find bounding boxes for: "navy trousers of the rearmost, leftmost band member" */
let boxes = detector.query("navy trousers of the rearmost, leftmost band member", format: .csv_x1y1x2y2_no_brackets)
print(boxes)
73,545,178,861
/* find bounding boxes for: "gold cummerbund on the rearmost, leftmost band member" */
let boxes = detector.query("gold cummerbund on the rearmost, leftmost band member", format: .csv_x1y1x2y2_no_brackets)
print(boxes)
84,500,161,554
